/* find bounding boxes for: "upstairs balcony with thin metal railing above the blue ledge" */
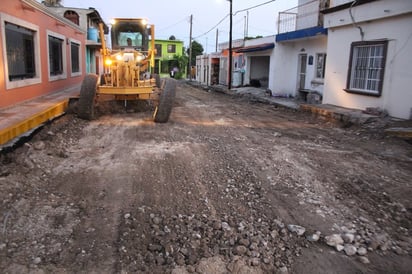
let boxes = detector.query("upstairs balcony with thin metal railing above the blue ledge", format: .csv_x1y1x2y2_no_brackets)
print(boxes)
278,0,329,33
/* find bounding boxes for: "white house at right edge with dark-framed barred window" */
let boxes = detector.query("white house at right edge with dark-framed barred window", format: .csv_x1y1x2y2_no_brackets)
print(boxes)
323,0,412,119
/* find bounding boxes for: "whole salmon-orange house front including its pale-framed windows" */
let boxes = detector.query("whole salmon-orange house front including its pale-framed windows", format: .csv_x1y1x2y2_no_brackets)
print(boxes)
0,0,86,108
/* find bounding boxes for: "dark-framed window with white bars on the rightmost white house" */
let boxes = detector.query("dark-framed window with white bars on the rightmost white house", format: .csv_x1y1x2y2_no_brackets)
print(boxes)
345,41,388,96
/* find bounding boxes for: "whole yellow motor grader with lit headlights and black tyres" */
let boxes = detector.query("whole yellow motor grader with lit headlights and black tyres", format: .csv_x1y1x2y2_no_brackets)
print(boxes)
78,18,176,123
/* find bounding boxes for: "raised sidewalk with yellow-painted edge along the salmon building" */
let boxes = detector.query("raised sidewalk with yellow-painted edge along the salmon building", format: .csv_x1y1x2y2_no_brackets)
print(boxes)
0,86,80,150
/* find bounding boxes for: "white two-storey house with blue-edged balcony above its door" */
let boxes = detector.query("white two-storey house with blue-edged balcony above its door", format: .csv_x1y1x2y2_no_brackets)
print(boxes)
269,0,329,98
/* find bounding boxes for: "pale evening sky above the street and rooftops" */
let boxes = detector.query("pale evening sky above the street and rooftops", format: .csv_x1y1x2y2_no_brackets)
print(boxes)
56,0,298,53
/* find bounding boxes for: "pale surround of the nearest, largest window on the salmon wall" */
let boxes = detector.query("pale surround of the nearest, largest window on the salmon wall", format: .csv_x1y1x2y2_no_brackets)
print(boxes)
0,12,41,89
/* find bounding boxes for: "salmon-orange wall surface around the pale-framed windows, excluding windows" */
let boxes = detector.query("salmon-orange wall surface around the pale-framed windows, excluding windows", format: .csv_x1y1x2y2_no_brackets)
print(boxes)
0,0,86,108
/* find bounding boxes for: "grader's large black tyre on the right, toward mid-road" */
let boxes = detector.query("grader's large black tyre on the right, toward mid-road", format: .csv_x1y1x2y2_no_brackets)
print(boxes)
153,78,176,123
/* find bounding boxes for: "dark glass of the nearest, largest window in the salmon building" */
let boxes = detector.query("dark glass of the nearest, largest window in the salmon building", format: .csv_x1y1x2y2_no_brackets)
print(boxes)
5,22,36,82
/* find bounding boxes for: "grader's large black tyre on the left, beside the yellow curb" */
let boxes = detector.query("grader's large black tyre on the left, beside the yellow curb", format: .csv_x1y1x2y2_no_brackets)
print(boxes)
77,74,98,120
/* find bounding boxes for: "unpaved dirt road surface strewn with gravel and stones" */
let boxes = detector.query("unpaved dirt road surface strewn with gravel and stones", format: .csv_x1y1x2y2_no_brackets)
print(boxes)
0,83,412,273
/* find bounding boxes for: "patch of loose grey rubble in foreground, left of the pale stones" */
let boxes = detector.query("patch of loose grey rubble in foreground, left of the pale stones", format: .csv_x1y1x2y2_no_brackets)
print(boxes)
119,208,306,273
